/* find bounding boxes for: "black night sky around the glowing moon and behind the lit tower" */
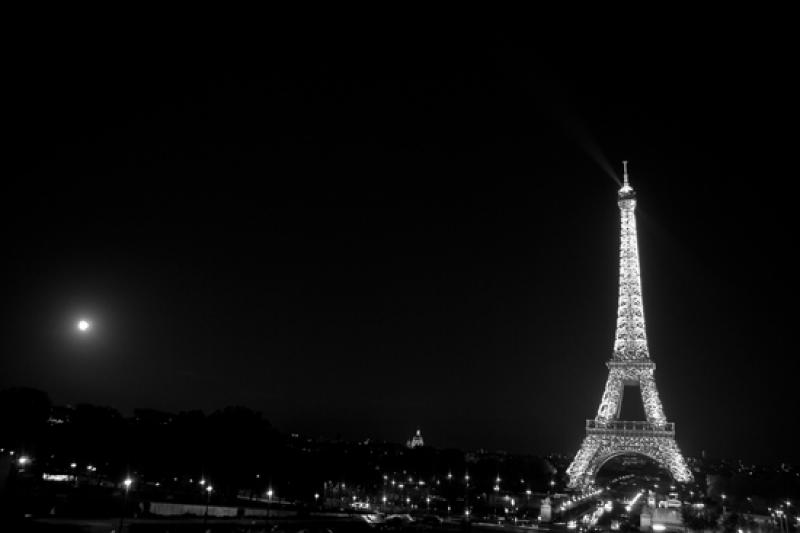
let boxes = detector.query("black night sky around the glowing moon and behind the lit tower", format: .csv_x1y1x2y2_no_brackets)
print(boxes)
0,23,800,462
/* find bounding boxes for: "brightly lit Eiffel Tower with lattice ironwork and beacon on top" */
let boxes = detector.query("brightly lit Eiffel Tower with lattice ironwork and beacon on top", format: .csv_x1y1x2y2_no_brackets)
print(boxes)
567,161,692,489
